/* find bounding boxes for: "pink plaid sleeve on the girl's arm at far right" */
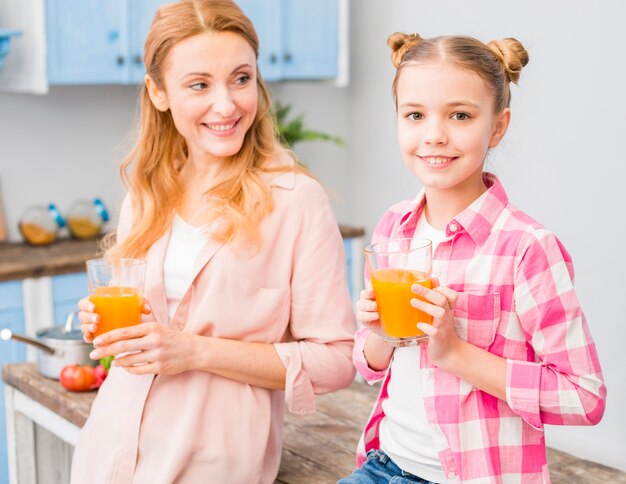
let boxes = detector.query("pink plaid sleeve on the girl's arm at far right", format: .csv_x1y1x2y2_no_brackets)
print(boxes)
506,229,606,428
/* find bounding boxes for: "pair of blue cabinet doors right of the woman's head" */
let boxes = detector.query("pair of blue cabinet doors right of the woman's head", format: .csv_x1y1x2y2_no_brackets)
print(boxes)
237,0,339,81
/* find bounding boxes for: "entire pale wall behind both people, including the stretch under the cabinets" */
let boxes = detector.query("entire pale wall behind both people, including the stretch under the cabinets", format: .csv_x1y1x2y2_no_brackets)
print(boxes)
0,0,626,470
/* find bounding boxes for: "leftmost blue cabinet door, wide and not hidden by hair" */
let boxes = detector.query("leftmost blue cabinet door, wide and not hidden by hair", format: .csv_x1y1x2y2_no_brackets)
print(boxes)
46,0,128,84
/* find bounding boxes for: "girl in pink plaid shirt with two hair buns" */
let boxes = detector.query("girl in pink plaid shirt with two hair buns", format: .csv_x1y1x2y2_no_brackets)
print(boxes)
340,33,606,484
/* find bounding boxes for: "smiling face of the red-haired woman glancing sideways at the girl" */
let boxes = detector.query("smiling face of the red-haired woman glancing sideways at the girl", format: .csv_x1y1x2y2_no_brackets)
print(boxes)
146,32,257,161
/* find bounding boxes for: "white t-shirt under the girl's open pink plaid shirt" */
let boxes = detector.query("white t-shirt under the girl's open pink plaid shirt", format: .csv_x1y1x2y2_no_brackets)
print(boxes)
379,212,446,482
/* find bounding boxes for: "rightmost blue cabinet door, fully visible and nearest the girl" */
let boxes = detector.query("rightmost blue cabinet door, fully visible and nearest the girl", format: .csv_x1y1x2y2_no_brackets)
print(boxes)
281,0,339,79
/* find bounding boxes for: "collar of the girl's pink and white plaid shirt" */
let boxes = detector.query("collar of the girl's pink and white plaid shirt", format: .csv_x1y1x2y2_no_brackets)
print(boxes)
399,172,509,245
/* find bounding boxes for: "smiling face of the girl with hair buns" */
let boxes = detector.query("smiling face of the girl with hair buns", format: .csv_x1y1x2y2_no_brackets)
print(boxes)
396,62,510,195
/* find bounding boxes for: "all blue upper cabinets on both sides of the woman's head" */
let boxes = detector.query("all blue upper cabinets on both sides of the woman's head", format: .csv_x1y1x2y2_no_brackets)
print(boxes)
46,0,339,85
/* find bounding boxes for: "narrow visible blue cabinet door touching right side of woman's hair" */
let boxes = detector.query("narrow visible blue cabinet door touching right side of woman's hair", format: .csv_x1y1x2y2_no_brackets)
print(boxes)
237,0,282,82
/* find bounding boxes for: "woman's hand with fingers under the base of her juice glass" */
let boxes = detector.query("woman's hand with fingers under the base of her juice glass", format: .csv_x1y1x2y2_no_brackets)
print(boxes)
89,322,199,375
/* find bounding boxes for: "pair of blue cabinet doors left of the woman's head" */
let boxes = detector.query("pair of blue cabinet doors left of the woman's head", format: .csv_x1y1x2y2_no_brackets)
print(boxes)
46,0,171,84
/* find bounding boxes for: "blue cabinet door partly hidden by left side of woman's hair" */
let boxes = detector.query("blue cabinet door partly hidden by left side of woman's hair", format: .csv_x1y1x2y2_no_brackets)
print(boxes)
127,0,172,84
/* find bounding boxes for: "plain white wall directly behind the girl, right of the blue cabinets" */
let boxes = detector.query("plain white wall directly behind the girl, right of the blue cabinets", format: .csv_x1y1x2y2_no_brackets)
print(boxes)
348,0,626,470
